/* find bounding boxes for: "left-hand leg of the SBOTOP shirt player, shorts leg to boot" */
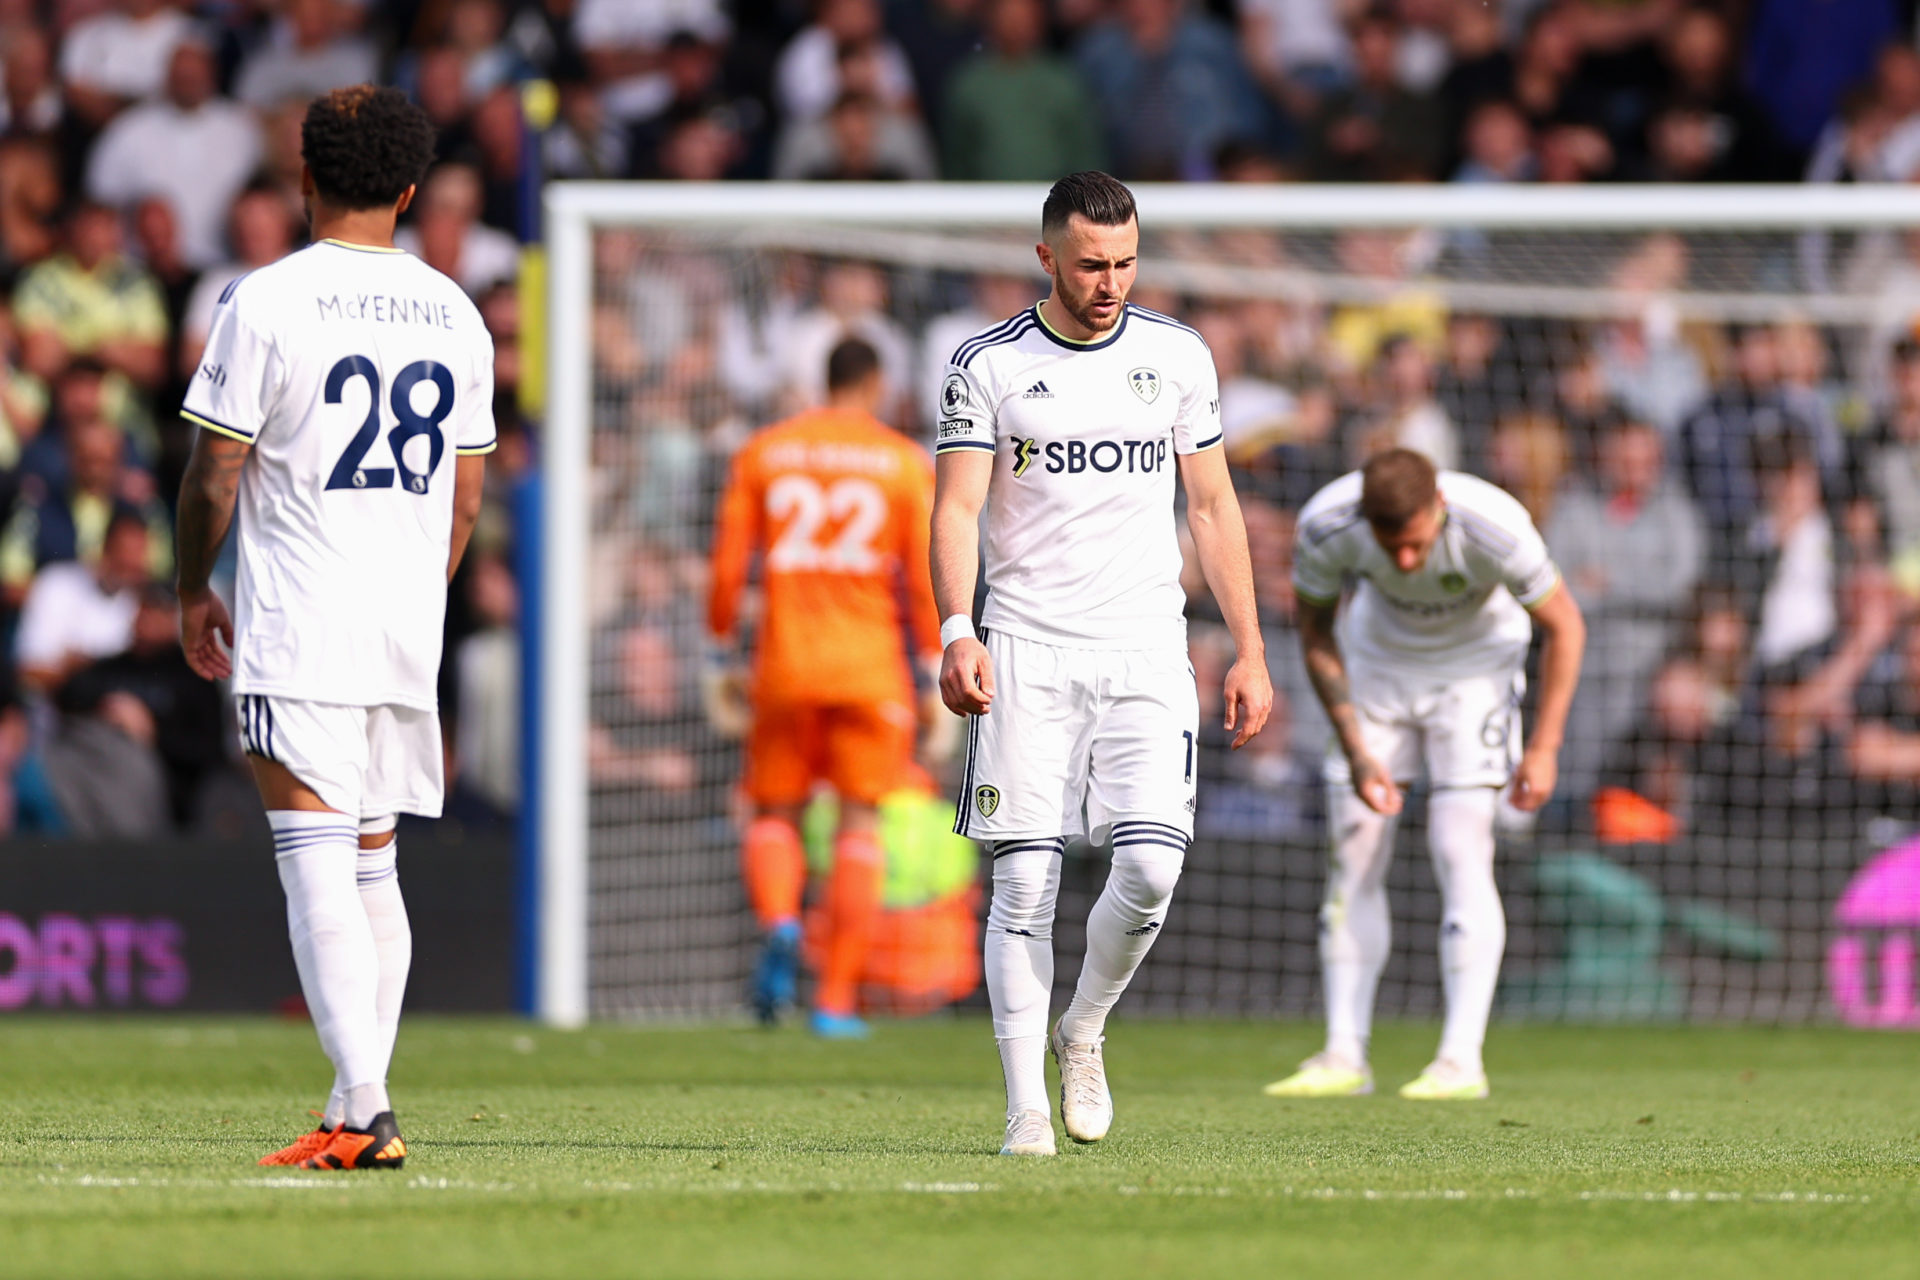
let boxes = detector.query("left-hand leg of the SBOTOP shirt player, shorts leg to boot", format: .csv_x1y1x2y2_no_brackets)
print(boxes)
954,631,1087,1155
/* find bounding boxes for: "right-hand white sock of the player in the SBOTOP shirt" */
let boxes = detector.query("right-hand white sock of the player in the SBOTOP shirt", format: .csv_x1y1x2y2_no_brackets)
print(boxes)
1060,821,1187,1044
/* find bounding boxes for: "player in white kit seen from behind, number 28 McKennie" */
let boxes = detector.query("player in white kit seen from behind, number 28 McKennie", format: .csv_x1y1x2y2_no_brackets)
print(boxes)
179,84,493,1169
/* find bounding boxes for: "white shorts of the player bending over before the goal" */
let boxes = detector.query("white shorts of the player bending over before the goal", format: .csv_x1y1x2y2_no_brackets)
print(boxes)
1327,660,1526,789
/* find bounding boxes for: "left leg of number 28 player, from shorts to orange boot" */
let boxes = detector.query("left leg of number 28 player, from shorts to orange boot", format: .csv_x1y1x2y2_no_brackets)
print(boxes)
242,697,397,1167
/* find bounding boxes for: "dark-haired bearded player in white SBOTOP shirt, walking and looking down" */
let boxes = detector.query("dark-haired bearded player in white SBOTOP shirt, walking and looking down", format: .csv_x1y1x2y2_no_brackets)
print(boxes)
933,173,1273,1155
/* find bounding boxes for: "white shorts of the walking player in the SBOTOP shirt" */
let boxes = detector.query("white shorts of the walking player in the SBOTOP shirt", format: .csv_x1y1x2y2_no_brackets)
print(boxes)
954,631,1200,842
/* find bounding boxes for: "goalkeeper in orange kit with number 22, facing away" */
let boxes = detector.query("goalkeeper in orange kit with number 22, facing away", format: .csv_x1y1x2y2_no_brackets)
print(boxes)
707,338,941,1038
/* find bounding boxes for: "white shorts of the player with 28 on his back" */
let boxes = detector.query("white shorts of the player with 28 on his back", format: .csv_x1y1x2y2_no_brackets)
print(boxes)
234,693,445,819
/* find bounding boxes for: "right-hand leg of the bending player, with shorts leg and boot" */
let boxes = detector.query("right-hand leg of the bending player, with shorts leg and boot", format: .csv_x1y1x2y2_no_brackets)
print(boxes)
1402,674,1521,1100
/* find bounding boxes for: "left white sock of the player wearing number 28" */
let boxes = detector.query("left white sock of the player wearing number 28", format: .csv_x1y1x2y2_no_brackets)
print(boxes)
267,810,388,1128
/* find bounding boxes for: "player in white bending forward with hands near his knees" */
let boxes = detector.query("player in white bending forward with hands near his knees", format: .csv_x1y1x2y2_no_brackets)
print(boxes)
1265,449,1586,1100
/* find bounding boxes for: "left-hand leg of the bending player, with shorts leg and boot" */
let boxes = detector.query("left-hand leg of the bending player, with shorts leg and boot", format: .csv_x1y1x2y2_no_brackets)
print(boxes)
1265,664,1419,1098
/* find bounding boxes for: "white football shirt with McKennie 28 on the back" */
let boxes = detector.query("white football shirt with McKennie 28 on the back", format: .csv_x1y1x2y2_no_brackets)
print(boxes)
180,240,493,710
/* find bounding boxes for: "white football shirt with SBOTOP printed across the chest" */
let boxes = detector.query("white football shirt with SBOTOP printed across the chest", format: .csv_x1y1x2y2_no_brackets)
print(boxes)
933,305,1221,649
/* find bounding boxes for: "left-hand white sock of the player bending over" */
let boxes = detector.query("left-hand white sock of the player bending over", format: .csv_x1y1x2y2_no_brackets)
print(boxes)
1319,785,1400,1067
